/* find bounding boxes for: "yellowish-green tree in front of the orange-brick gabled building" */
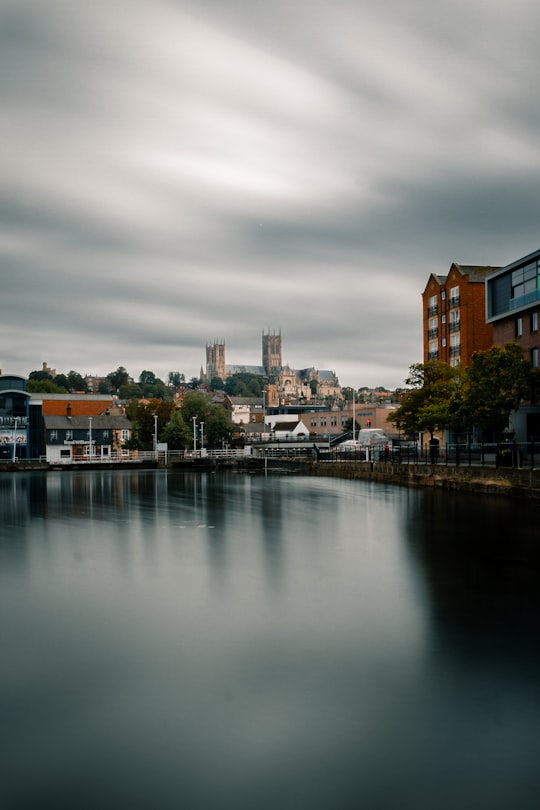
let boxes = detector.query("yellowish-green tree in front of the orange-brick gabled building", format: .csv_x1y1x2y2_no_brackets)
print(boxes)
387,360,463,439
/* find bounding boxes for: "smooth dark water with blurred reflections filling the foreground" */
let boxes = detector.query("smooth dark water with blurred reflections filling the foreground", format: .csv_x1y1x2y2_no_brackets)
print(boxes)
0,471,540,810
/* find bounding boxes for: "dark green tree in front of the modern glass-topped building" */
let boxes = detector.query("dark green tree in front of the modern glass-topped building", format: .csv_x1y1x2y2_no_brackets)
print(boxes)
455,343,535,441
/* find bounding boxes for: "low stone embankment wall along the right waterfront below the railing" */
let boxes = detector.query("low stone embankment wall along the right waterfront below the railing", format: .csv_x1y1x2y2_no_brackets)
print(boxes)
308,461,540,500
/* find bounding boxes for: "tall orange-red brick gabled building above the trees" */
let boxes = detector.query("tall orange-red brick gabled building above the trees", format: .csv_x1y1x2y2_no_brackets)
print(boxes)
422,262,500,367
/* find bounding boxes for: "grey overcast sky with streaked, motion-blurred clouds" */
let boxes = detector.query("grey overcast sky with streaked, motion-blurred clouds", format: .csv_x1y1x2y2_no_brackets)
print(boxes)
0,0,540,388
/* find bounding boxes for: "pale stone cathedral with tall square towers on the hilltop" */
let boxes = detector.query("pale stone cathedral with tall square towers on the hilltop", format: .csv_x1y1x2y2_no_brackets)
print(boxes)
201,330,342,407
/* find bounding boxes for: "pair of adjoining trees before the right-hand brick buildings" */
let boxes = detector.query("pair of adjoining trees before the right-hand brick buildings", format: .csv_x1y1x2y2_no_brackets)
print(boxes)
388,343,540,442
